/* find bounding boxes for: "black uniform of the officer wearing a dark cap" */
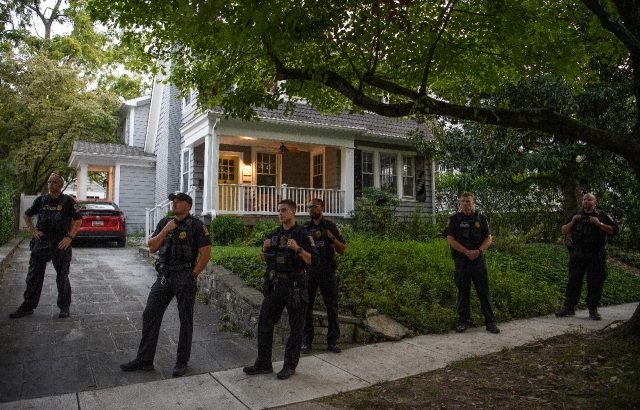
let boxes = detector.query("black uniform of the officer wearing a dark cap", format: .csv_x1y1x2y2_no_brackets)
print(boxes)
136,215,211,365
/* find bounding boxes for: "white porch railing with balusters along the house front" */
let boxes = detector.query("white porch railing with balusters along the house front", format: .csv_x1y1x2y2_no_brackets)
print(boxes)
216,184,345,216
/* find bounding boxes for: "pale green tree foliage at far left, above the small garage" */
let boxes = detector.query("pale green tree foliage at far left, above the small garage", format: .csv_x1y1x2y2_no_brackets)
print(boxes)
0,0,149,194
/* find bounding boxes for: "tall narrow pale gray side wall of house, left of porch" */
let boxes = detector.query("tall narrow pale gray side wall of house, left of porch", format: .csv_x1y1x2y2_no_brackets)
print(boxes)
155,85,182,203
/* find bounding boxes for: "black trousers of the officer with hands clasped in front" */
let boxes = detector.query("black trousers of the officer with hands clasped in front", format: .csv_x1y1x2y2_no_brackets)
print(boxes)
454,254,496,325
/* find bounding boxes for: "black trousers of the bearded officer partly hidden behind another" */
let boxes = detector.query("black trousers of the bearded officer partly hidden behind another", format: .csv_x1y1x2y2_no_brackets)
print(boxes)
304,272,340,346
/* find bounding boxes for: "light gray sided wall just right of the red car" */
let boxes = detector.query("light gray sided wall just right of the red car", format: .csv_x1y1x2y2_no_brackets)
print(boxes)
118,165,155,232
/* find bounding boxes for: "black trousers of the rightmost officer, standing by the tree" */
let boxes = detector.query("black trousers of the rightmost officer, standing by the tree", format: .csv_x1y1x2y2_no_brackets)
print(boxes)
564,247,607,309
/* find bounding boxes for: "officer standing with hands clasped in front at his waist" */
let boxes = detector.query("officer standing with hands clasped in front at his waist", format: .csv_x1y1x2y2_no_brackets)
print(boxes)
446,192,500,333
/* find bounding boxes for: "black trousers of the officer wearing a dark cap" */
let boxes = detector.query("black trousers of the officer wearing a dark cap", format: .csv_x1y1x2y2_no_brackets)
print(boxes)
137,270,197,365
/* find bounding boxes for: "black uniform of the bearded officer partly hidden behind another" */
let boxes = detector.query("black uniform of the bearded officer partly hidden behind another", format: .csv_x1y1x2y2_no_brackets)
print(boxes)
304,218,345,346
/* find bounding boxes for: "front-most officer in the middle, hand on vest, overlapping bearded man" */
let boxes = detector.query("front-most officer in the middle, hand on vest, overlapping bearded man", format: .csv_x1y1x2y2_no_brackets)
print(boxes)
242,199,317,379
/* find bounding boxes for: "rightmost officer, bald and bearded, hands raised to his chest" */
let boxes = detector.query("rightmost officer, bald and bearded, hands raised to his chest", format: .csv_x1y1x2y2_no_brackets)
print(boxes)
556,193,618,320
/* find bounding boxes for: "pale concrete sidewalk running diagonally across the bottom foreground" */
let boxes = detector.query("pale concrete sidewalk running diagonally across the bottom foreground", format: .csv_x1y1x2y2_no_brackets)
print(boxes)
0,303,637,410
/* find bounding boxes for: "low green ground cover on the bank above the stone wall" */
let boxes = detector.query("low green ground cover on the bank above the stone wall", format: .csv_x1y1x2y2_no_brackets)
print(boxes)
213,239,640,333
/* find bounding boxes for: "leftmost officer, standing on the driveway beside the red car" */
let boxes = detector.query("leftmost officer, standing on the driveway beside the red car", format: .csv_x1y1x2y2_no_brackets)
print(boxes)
9,174,82,319
